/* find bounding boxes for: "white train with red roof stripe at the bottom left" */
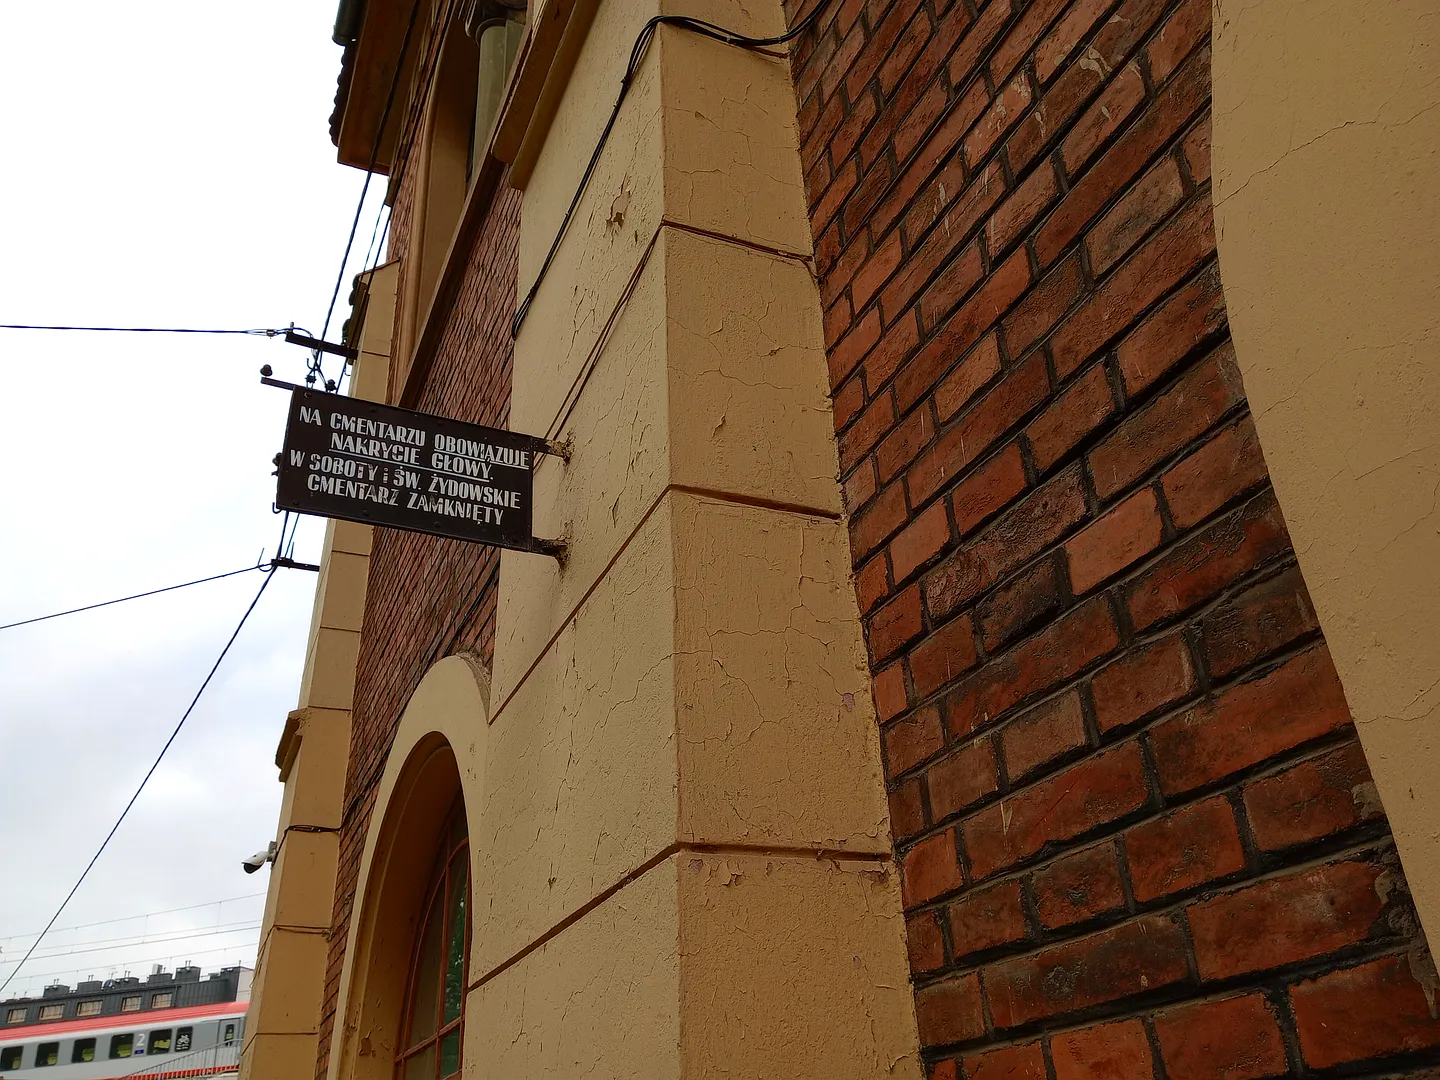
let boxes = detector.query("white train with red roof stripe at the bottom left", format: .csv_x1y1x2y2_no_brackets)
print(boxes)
0,1001,249,1080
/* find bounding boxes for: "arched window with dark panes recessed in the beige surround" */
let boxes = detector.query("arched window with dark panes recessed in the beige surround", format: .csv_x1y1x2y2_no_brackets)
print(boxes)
395,804,469,1080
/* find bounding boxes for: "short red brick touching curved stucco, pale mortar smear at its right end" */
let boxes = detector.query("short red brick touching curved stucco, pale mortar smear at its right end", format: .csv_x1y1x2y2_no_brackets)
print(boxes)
1244,742,1385,851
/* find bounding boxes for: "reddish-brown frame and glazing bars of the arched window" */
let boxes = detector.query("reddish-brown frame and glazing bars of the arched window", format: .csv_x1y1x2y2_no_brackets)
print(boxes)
395,799,474,1080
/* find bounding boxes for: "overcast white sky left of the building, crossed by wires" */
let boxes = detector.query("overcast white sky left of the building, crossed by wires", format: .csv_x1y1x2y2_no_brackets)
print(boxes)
0,0,383,998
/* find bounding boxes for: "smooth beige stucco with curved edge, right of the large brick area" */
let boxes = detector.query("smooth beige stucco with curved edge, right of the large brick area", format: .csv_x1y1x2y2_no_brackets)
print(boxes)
1214,0,1440,945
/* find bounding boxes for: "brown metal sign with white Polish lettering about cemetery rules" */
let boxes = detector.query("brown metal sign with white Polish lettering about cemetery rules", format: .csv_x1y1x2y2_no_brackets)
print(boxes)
275,386,559,554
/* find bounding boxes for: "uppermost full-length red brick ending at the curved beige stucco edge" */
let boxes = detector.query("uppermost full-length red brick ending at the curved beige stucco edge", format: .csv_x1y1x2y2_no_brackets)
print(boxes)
1035,49,1210,266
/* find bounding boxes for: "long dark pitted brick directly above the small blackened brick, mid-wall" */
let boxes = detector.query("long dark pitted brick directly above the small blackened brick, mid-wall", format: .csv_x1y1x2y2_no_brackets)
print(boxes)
924,467,1086,616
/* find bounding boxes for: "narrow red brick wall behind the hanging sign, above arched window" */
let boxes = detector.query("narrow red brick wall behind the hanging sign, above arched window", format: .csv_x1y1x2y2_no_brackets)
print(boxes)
317,148,520,1077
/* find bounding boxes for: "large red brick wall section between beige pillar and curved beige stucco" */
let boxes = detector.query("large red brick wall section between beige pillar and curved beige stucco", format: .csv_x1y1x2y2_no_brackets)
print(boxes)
793,0,1440,1080
